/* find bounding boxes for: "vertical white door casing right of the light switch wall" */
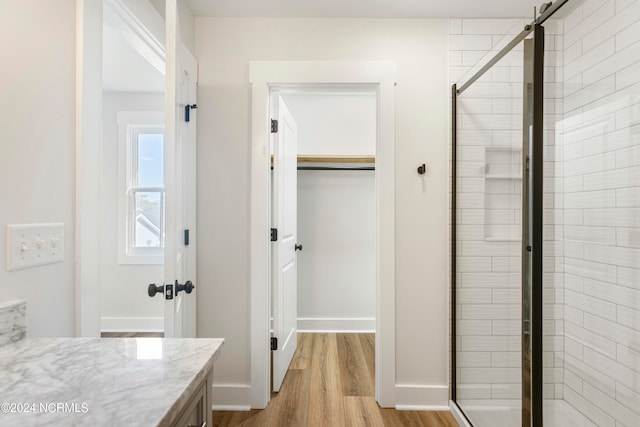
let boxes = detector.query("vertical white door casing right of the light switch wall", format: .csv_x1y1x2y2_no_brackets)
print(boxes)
75,0,102,337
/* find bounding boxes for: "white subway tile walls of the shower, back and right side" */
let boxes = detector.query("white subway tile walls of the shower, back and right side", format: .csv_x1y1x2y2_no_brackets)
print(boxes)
449,0,640,427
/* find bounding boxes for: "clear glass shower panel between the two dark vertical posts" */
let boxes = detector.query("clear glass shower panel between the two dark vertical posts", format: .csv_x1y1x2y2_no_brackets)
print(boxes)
455,34,529,427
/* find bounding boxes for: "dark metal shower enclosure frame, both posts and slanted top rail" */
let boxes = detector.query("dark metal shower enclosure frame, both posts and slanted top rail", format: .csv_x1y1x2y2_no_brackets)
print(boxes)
451,19,552,427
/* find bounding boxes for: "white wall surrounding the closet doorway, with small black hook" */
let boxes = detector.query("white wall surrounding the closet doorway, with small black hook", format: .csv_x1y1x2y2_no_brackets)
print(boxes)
196,18,448,405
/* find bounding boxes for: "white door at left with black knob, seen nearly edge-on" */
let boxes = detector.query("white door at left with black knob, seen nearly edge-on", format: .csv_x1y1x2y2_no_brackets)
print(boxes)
164,1,197,338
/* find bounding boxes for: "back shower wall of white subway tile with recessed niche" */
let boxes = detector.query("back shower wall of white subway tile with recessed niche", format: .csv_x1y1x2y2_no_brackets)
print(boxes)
450,15,562,406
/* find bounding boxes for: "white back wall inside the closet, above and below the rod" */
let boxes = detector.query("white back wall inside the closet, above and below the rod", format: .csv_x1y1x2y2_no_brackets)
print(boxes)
282,93,377,332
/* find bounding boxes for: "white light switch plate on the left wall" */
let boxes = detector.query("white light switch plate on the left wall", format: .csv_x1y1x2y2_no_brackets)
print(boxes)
7,223,64,271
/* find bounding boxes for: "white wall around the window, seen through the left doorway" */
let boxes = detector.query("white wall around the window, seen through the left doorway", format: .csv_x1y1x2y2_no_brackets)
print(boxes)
100,92,164,331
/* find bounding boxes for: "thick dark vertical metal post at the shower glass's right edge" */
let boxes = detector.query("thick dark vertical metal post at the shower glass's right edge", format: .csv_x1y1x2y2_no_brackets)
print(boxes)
521,24,544,427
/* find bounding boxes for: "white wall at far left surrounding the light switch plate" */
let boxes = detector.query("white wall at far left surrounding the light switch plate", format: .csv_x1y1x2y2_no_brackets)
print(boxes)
0,0,75,336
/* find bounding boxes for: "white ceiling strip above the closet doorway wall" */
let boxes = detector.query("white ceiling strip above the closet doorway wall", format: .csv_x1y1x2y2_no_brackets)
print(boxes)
187,0,543,18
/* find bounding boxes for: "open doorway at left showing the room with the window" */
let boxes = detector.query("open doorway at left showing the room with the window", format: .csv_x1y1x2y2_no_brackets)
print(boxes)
99,0,165,337
